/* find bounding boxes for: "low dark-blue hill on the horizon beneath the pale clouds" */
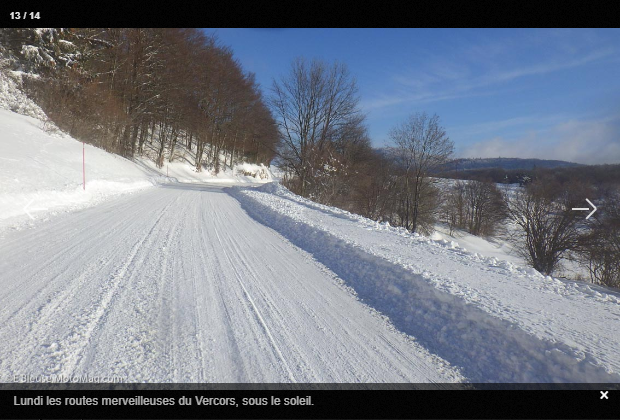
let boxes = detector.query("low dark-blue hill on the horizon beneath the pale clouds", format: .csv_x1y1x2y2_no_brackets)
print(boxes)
445,158,583,171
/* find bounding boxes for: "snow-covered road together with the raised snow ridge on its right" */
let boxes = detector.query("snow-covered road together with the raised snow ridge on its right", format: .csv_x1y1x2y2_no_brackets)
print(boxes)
0,149,620,383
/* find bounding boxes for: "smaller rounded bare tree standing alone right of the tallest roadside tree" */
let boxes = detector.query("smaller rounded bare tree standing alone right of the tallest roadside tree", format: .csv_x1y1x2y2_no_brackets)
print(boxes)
389,113,454,232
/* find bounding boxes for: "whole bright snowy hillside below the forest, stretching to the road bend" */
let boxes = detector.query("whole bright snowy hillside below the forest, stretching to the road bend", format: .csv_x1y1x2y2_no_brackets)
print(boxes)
0,72,272,228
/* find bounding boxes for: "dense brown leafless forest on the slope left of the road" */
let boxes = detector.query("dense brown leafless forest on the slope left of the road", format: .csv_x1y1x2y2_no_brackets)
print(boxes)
0,28,278,173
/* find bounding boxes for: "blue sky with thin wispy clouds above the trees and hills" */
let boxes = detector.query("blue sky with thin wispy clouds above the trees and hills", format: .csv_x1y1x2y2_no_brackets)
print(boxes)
206,28,620,163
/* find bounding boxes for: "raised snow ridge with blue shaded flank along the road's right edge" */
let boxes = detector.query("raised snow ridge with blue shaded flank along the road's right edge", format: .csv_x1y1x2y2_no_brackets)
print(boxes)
231,184,620,382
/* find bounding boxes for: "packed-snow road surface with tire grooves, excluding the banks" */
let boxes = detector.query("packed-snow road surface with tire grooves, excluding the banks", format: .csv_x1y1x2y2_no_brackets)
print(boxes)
0,184,463,382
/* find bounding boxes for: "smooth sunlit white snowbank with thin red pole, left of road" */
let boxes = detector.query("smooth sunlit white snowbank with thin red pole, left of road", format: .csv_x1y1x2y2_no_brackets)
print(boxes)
0,109,163,228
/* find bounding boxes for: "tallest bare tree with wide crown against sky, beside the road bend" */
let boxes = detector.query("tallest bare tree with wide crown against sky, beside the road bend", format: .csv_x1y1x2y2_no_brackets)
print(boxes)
270,58,365,196
